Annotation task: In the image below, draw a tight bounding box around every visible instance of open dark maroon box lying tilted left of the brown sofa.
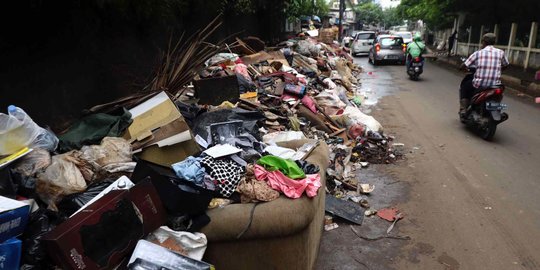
[42,180,166,270]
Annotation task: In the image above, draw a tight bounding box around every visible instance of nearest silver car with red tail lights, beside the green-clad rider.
[368,35,407,65]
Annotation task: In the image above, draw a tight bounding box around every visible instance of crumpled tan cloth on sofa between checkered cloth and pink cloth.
[237,164,279,203]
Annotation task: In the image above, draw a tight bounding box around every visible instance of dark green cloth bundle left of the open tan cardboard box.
[58,108,133,153]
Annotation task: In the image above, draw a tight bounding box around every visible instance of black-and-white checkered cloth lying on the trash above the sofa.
[201,156,245,198]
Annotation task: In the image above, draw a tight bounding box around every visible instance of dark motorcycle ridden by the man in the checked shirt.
[459,60,508,141]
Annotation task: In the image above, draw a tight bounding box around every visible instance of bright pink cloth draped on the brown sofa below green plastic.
[255,165,321,199]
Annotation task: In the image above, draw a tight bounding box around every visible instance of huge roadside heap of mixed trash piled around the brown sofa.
[0,30,398,269]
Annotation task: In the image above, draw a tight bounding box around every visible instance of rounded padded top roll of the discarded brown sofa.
[201,140,329,241]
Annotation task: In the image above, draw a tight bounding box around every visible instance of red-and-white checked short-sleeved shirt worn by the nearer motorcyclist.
[465,46,508,88]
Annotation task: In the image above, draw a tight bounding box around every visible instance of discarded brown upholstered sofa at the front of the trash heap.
[202,140,329,270]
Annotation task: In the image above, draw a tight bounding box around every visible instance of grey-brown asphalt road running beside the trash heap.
[356,57,540,269]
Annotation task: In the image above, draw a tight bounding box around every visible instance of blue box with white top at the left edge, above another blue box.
[0,196,30,242]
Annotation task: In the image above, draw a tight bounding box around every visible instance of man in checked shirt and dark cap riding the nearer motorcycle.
[459,33,509,116]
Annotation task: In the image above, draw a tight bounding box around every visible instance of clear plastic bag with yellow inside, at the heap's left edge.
[0,106,58,156]
